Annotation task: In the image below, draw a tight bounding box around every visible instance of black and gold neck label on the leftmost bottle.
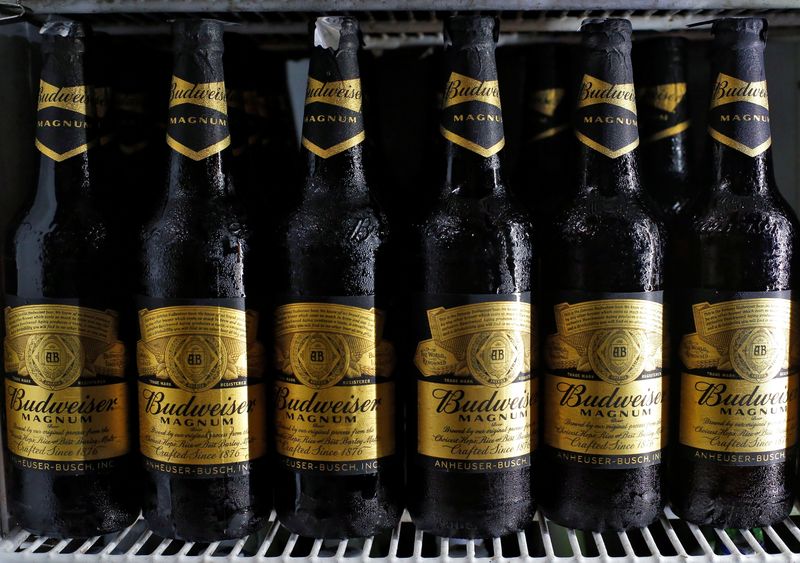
[36,77,96,162]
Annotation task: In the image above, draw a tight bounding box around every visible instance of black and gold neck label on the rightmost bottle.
[708,72,772,157]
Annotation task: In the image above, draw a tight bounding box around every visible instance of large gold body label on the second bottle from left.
[137,298,267,478]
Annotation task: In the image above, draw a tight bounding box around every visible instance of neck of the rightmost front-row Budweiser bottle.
[709,43,776,196]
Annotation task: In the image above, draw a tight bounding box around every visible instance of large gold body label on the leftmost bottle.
[4,304,131,472]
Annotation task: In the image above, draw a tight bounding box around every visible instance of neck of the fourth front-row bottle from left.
[440,38,505,198]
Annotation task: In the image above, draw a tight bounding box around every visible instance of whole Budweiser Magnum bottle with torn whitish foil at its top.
[273,16,402,538]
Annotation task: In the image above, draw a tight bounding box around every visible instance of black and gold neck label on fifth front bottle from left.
[575,74,639,158]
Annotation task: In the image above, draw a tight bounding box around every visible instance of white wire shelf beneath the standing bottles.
[0,510,800,563]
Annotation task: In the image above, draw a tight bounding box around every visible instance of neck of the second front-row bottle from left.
[167,46,233,200]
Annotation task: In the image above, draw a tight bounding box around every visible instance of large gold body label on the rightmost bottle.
[679,290,800,466]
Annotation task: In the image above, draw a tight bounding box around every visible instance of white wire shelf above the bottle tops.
[9,0,800,39]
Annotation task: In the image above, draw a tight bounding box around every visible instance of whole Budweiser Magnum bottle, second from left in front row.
[137,20,271,542]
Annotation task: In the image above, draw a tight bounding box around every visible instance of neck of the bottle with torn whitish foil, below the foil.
[301,43,369,199]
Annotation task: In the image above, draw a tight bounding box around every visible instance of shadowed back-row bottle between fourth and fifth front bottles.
[515,43,573,220]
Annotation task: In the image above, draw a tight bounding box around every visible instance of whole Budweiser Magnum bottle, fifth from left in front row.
[537,19,667,532]
